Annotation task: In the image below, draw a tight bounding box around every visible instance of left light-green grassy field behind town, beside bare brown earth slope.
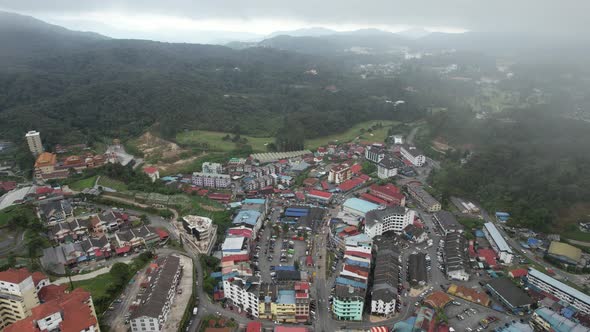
[176,130,274,152]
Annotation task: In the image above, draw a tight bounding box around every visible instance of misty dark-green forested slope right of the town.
[429,105,590,231]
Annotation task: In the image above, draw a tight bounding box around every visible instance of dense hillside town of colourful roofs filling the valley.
[0,127,590,332]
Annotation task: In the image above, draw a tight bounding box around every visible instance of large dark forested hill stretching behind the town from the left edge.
[0,12,432,144]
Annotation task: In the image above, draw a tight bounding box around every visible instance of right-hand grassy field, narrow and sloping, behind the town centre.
[305,120,398,149]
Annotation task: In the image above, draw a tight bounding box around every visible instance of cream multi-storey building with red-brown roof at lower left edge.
[0,269,40,330]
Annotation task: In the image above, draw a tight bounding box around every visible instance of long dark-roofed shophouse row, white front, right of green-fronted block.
[371,237,401,317]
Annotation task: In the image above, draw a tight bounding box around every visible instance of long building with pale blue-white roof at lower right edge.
[527,268,590,315]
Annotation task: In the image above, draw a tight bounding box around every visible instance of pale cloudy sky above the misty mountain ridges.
[0,0,590,42]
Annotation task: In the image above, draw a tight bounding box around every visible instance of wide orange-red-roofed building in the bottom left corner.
[4,288,100,332]
